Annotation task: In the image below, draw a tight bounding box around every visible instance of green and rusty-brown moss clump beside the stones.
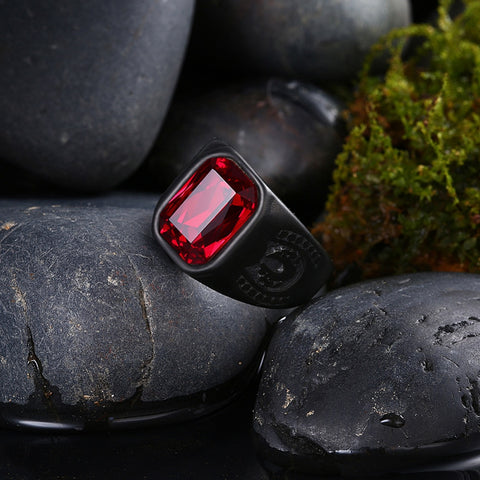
[314,0,480,277]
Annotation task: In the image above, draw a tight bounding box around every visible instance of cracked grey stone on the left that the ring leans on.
[0,204,268,429]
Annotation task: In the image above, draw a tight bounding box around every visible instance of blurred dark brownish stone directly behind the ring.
[148,79,343,222]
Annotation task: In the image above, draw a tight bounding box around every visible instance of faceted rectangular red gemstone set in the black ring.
[158,157,258,265]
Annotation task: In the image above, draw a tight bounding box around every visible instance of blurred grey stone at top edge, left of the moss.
[192,0,410,80]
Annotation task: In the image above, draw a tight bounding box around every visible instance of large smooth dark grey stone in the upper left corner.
[0,0,194,190]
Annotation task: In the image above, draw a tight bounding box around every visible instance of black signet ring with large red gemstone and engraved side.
[152,140,332,308]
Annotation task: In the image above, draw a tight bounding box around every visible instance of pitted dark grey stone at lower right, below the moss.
[254,273,480,475]
